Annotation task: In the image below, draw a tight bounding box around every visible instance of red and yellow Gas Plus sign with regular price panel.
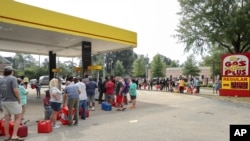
[220,53,250,96]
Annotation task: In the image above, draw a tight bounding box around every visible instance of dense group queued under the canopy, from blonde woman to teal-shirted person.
[43,76,137,128]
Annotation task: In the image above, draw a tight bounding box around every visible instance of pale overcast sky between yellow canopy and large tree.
[1,0,189,63]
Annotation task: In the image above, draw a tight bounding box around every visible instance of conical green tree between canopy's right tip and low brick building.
[151,54,166,77]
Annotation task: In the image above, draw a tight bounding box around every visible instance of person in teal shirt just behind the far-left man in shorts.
[17,78,28,120]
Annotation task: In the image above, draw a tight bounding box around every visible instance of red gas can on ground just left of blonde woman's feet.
[37,120,53,133]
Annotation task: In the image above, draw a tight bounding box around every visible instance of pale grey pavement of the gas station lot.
[0,85,250,141]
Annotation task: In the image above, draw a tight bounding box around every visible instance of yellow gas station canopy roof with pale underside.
[0,0,137,57]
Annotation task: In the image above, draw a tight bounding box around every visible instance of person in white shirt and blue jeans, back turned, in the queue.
[74,78,88,120]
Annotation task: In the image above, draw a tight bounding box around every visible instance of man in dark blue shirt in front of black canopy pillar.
[86,77,97,111]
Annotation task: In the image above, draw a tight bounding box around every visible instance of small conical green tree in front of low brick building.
[182,55,201,78]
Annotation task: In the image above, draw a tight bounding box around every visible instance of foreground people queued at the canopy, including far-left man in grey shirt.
[0,67,137,140]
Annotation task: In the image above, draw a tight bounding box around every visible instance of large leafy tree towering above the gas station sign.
[175,0,250,53]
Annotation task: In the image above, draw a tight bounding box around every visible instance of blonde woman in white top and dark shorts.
[49,78,62,128]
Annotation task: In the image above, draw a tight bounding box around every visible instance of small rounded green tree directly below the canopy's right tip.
[132,56,146,77]
